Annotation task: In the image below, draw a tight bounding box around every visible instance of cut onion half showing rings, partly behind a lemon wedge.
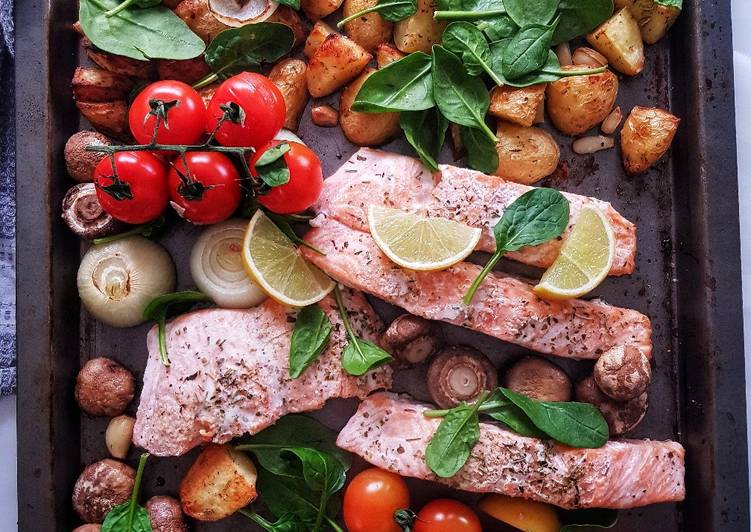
[190,219,266,308]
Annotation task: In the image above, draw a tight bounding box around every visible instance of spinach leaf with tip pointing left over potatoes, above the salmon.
[352,52,435,113]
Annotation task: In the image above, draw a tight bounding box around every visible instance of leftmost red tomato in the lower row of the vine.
[94,151,169,224]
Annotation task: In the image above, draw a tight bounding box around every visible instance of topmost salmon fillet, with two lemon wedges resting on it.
[311,148,636,275]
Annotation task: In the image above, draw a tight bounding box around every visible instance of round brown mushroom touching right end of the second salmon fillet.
[593,345,652,401]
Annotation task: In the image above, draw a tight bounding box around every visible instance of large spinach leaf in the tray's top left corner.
[78,0,206,61]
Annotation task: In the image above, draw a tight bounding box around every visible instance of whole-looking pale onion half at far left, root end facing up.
[78,236,175,327]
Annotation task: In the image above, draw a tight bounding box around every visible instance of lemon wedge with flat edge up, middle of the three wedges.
[368,205,482,271]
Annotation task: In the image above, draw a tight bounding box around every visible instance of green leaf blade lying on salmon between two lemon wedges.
[493,188,569,252]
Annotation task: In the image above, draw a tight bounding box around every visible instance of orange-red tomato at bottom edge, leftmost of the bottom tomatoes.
[344,467,409,532]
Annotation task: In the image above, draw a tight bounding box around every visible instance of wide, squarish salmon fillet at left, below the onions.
[133,291,391,456]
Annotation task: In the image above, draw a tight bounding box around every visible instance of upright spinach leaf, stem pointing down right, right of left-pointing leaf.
[433,45,498,142]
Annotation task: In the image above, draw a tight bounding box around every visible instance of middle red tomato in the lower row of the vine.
[168,151,242,225]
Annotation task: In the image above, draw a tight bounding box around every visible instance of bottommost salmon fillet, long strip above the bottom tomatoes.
[336,393,685,509]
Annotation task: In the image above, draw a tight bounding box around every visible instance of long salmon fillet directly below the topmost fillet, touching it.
[303,219,652,359]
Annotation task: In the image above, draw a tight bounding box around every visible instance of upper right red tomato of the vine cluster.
[206,72,286,148]
